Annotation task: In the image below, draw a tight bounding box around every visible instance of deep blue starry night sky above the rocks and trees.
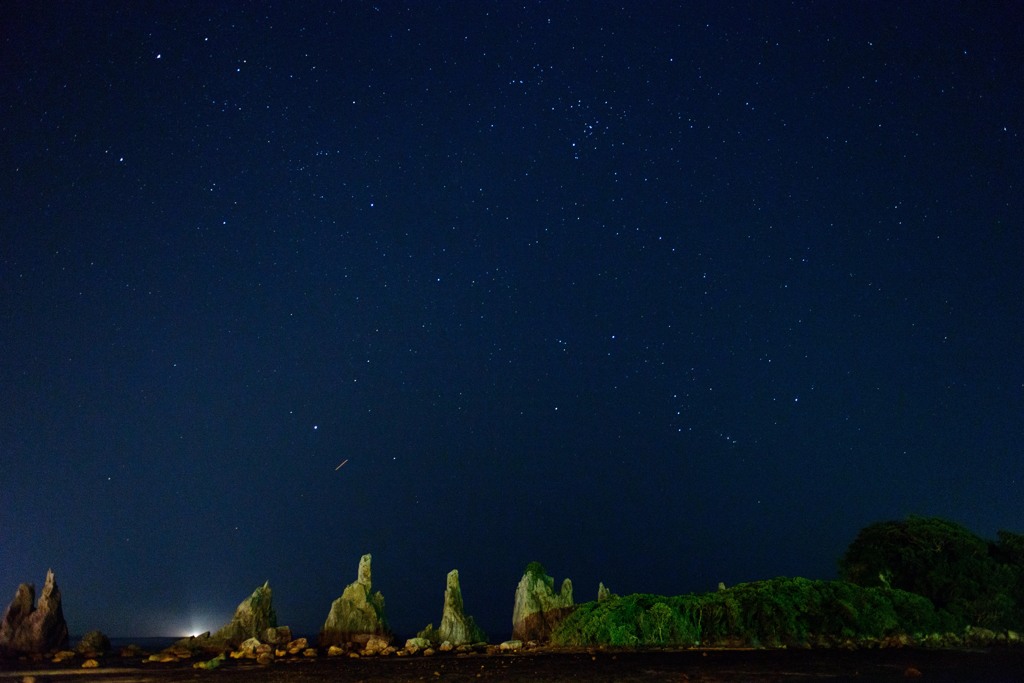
[0,0,1024,641]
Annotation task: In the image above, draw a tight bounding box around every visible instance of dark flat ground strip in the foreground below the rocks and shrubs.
[0,649,1024,683]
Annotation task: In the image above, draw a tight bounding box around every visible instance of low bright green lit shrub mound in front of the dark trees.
[552,578,947,646]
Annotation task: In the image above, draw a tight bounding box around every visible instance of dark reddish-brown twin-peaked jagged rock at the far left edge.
[0,569,68,653]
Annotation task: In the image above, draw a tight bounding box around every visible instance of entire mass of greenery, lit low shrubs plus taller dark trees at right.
[552,517,1024,647]
